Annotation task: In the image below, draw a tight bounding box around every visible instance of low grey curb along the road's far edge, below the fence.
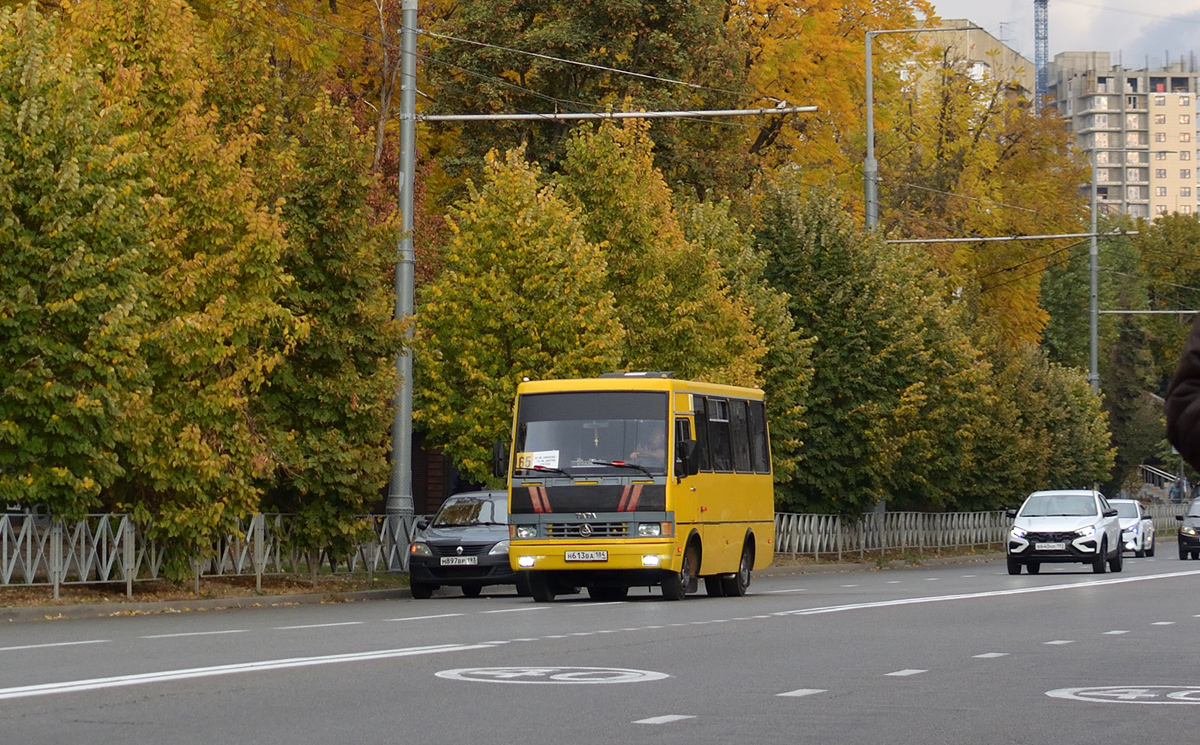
[0,553,1004,624]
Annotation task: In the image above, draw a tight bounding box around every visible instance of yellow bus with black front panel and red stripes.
[494,372,775,602]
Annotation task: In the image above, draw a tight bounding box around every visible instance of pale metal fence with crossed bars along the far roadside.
[0,504,1187,597]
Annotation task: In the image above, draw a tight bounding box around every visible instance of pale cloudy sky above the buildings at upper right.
[932,0,1200,70]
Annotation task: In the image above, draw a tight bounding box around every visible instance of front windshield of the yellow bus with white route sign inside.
[514,391,668,477]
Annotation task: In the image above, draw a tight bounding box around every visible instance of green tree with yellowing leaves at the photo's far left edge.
[0,5,151,521]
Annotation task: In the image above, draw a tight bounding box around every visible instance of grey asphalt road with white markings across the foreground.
[0,551,1200,745]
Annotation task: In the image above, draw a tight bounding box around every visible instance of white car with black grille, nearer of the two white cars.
[1007,489,1124,575]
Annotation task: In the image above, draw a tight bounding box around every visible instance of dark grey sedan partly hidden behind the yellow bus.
[408,492,527,600]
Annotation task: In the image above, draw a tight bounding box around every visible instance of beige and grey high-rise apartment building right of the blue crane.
[1049,52,1200,217]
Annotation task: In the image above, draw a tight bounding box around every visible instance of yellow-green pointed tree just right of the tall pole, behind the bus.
[414,151,625,481]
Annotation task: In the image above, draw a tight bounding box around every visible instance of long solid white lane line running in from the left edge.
[0,644,490,701]
